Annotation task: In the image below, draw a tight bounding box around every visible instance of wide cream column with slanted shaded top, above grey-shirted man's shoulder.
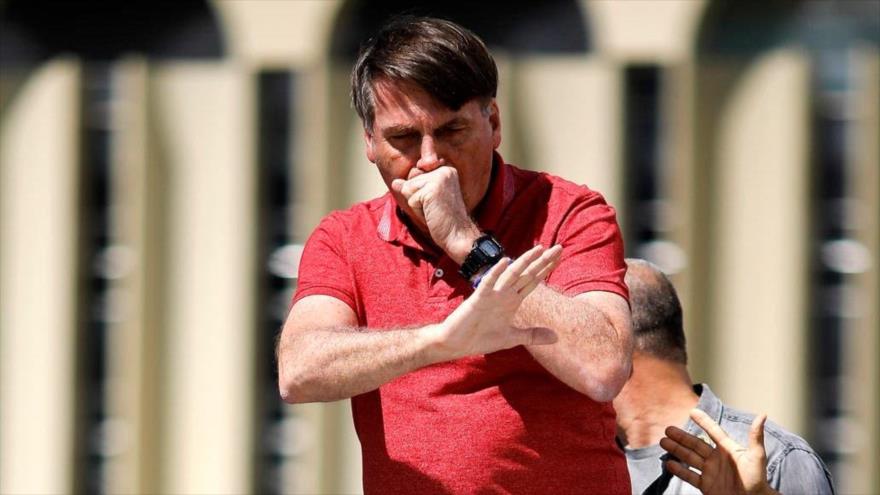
[706,50,809,433]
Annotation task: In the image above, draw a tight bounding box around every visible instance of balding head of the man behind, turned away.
[626,258,687,364]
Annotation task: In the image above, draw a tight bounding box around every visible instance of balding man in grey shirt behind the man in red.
[614,259,834,494]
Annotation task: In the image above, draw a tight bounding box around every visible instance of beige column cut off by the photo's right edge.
[835,46,880,493]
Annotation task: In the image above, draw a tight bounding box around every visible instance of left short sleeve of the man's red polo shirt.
[292,214,357,312]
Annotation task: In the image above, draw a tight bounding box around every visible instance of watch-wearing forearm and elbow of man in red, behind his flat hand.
[514,284,633,402]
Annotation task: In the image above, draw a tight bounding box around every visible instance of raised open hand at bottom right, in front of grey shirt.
[660,409,776,495]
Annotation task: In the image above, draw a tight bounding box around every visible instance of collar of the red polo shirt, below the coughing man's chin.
[376,152,516,251]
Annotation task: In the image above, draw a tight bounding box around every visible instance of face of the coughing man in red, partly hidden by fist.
[364,79,501,218]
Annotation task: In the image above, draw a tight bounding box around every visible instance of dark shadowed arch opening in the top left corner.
[0,0,226,112]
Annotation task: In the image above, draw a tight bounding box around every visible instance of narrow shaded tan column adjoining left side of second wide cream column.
[105,58,167,493]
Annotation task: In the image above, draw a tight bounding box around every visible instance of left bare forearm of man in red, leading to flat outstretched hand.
[278,326,438,403]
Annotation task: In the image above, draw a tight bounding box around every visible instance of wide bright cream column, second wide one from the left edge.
[149,63,256,494]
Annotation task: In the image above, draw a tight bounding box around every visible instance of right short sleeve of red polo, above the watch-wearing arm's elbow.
[547,191,629,300]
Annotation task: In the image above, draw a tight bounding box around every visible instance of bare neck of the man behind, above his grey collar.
[614,355,699,449]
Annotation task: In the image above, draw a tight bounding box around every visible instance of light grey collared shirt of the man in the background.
[624,384,834,495]
